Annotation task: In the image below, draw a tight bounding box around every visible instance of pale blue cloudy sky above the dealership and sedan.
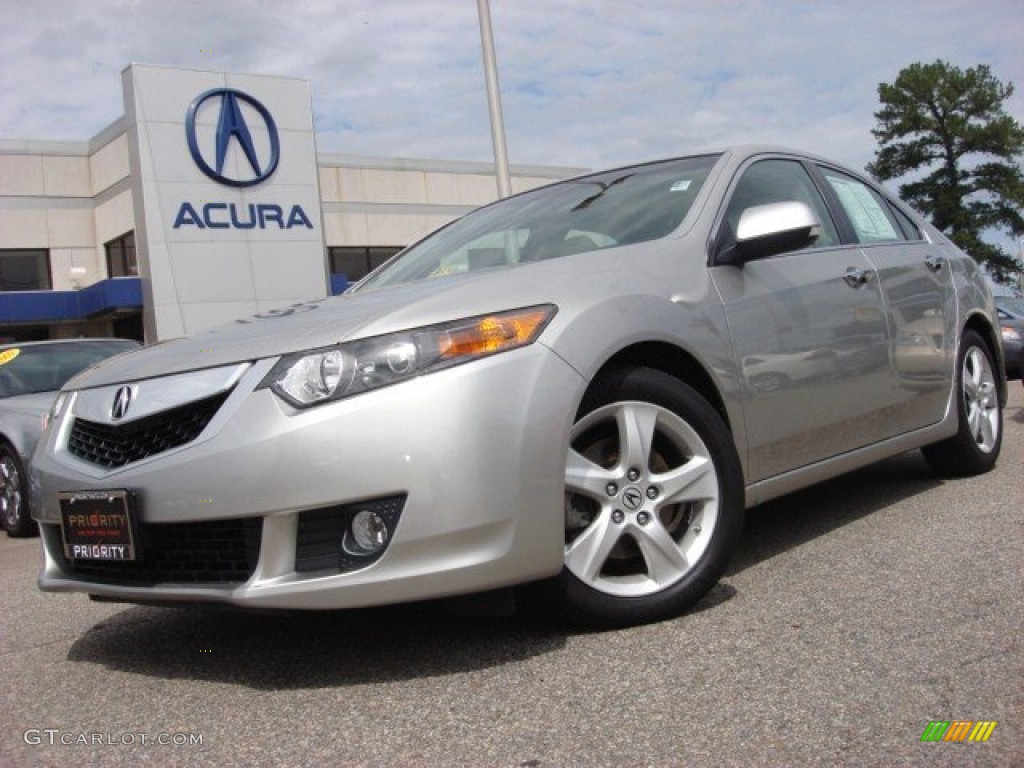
[0,0,1024,180]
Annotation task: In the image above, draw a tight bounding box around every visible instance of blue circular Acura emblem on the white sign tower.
[185,88,281,186]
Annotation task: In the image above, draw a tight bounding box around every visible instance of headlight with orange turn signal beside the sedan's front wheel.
[260,304,557,408]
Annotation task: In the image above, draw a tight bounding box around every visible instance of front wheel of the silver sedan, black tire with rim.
[556,369,744,627]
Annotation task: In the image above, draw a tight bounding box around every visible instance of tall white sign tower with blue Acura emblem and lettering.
[123,65,328,342]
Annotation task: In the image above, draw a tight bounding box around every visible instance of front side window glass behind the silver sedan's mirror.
[719,160,839,248]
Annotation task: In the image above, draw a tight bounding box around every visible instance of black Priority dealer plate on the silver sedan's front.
[58,490,136,560]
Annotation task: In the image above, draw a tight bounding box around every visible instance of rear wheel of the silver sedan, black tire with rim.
[921,331,1002,477]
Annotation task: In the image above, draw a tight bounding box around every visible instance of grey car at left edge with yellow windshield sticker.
[0,339,140,537]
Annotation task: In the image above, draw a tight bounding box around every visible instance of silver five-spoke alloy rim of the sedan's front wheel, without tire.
[565,401,720,597]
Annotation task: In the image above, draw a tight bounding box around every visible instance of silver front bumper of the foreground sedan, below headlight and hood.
[32,344,584,609]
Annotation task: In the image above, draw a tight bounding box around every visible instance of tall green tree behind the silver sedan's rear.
[867,59,1024,283]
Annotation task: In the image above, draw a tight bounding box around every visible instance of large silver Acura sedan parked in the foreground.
[32,146,1007,626]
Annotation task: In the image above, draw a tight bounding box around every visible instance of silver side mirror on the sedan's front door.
[718,201,821,266]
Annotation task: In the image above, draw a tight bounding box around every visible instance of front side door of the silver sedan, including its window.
[711,158,889,481]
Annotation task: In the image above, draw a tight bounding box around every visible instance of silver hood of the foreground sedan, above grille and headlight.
[65,258,579,390]
